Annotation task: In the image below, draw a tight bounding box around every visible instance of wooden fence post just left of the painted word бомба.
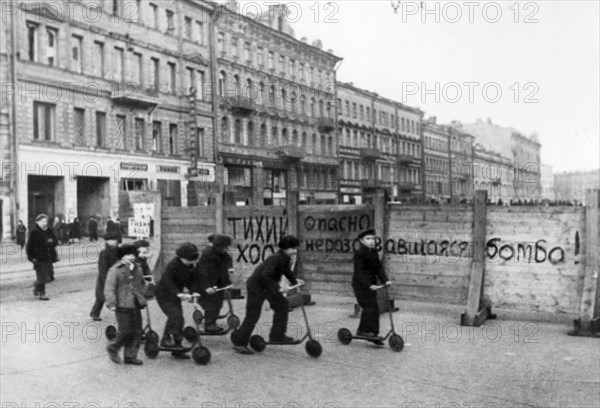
[460,190,496,326]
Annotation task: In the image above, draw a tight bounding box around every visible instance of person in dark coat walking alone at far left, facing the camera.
[26,214,58,300]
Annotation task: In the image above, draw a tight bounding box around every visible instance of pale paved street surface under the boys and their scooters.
[0,274,600,408]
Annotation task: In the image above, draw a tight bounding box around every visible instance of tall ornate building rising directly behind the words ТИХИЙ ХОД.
[215,2,341,205]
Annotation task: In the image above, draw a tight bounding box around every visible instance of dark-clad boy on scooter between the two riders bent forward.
[193,234,233,334]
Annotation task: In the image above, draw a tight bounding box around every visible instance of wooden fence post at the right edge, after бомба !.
[568,190,600,337]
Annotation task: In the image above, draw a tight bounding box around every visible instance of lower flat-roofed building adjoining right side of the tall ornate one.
[337,82,423,204]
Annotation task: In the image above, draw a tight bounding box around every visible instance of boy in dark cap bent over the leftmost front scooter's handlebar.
[155,243,200,359]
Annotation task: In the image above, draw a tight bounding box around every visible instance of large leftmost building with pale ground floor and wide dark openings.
[2,0,215,236]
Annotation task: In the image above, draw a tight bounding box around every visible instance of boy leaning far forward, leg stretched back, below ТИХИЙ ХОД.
[231,235,304,354]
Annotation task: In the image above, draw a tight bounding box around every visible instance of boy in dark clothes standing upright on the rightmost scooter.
[352,228,392,344]
